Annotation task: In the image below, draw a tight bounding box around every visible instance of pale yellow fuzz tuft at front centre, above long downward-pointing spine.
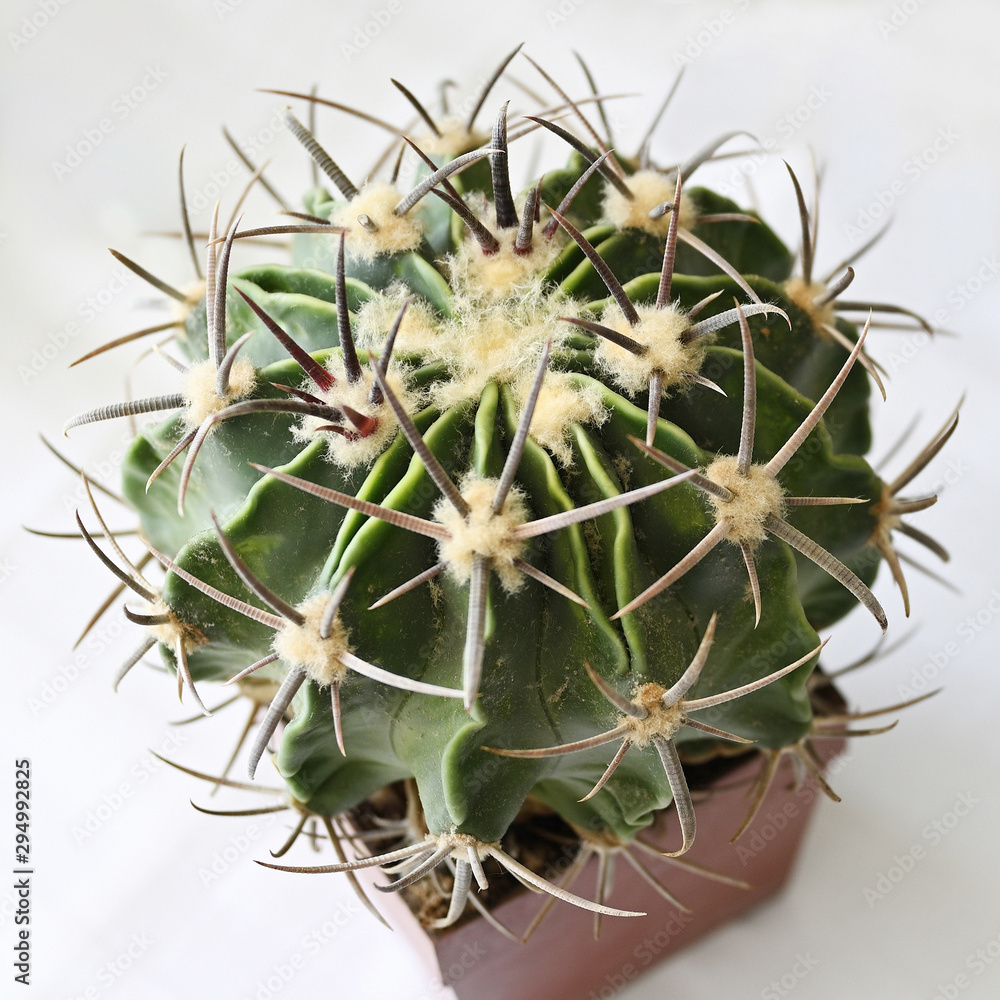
[434,477,528,593]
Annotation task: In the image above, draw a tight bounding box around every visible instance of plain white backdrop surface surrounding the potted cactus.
[0,0,1000,1000]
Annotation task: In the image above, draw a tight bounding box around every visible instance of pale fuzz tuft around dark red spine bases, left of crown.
[293,354,419,469]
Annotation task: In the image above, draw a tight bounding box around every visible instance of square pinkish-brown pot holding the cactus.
[368,740,843,1000]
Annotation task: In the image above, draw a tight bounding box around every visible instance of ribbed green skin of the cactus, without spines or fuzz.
[124,141,883,842]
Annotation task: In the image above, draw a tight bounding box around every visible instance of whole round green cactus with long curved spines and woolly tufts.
[62,50,957,927]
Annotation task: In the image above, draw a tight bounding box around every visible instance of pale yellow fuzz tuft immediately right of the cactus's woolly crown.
[595,303,705,396]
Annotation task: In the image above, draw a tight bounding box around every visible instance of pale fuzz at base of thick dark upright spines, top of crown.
[449,225,561,301]
